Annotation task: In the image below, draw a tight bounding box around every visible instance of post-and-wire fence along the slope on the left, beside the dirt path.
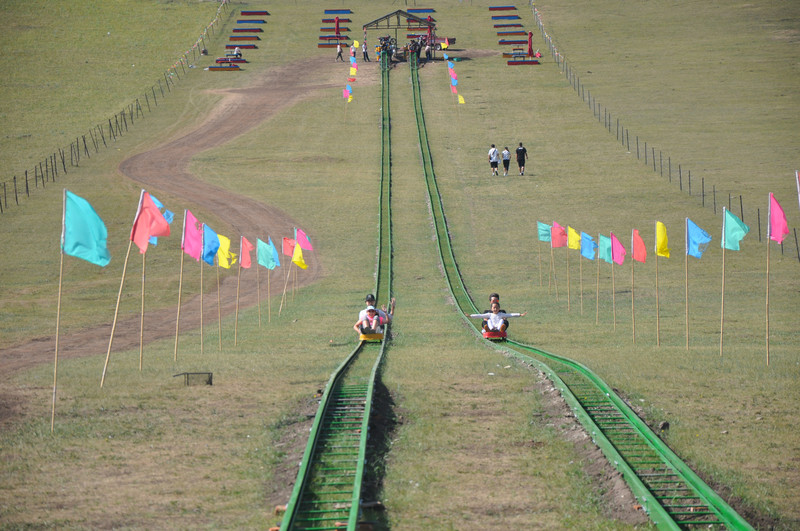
[0,0,230,214]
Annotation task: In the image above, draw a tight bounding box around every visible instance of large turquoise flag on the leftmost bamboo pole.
[61,190,111,267]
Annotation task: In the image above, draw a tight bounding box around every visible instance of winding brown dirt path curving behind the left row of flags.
[0,56,341,378]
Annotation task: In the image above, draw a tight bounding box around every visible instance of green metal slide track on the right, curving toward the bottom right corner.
[411,55,752,530]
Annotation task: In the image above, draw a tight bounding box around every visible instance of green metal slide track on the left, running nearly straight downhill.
[281,57,392,531]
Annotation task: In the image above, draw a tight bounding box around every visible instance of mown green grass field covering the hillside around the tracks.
[0,0,800,529]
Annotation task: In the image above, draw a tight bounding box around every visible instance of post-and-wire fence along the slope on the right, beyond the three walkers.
[530,0,800,262]
